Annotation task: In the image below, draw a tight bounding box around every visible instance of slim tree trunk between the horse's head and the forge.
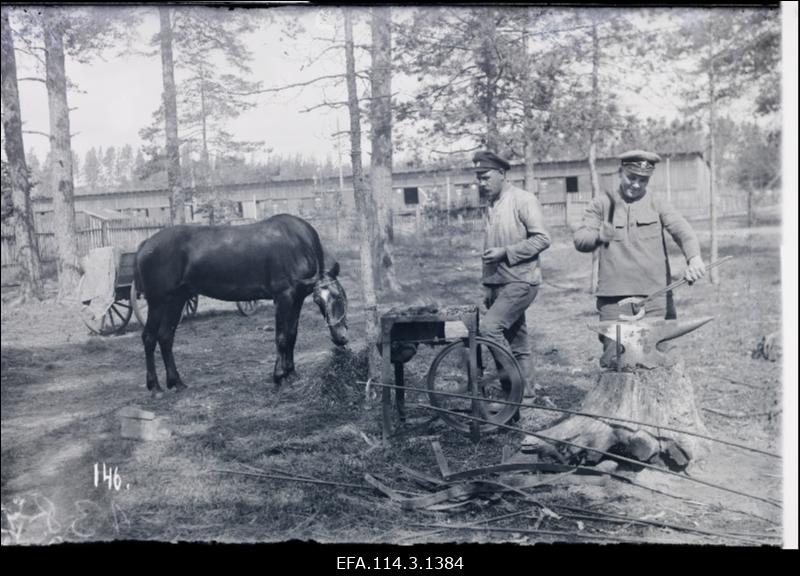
[342,8,381,378]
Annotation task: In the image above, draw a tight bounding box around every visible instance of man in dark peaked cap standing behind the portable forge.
[472,151,550,404]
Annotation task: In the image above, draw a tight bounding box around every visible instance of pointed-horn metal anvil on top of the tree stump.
[589,316,714,370]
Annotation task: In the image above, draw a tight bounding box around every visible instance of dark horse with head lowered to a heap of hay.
[135,214,347,395]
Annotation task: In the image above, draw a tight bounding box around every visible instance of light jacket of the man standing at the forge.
[483,183,550,286]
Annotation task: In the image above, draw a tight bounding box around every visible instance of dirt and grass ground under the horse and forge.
[1,216,782,546]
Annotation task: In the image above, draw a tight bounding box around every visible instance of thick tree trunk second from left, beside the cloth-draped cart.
[42,7,80,301]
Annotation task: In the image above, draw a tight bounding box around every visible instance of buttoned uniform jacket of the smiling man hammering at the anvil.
[574,193,700,296]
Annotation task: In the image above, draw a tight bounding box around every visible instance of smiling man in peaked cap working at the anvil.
[574,150,705,367]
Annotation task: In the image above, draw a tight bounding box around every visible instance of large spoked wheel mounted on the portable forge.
[427,336,524,433]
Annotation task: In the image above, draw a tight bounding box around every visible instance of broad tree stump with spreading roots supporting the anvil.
[522,361,708,470]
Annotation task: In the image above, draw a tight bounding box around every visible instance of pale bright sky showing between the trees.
[9,7,788,163]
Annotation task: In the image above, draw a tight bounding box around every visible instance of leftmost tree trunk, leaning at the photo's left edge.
[0,11,44,302]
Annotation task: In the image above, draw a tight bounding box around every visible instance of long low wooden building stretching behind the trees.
[2,152,746,269]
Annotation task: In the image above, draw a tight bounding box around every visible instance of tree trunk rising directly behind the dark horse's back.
[158,6,186,224]
